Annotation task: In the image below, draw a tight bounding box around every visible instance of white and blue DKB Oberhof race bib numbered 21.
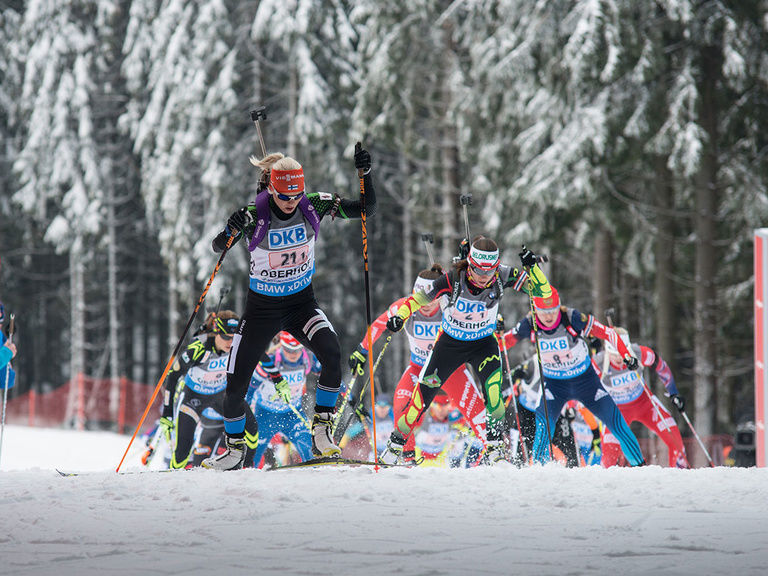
[250,210,315,296]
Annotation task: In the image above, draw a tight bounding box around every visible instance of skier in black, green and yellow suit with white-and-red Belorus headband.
[381,236,550,464]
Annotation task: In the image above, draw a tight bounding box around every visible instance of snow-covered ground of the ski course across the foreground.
[0,426,768,576]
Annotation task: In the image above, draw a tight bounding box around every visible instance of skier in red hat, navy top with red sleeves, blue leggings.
[504,287,645,466]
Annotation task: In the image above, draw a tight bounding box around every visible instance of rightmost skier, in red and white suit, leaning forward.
[594,328,690,468]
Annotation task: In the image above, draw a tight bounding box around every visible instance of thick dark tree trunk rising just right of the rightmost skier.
[694,47,721,436]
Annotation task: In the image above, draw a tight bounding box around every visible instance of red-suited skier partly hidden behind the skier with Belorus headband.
[349,264,486,461]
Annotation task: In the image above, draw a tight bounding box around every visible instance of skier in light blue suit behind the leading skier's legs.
[245,332,321,466]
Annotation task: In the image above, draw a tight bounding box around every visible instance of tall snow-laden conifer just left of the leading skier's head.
[121,0,240,341]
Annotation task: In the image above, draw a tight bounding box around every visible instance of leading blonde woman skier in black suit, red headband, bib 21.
[203,147,376,470]
